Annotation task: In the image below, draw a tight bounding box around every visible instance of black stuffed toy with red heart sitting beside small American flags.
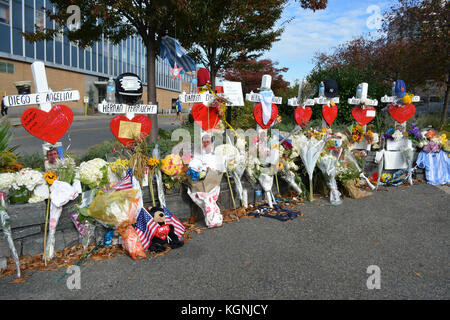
[148,207,184,252]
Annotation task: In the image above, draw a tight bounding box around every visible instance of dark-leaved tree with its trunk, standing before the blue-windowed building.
[25,0,187,141]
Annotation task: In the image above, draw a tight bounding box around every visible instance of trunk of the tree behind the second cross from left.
[145,40,160,142]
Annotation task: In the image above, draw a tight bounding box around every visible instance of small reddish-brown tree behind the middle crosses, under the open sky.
[218,59,289,95]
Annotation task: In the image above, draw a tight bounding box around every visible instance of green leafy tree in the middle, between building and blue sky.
[179,0,327,86]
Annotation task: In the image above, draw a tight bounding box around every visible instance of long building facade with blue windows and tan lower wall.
[0,0,191,111]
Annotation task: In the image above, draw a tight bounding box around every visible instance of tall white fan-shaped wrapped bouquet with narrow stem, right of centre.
[293,134,325,201]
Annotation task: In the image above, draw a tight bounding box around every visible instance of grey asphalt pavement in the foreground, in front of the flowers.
[0,184,450,300]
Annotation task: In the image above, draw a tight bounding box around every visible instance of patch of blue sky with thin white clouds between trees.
[260,0,396,85]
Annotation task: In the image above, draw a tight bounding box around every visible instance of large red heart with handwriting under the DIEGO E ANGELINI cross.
[21,105,73,144]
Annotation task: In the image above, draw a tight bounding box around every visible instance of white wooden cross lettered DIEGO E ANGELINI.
[3,61,80,112]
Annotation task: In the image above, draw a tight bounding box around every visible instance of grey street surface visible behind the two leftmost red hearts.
[11,116,186,155]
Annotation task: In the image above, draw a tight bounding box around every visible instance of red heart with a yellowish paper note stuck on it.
[109,114,152,146]
